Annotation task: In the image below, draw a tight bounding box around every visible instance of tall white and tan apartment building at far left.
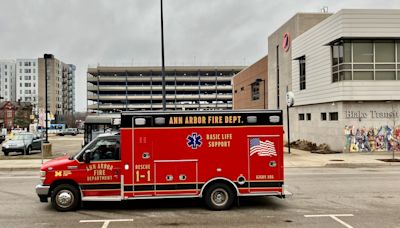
[0,56,76,115]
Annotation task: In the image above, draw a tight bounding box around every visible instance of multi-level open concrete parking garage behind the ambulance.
[87,66,244,113]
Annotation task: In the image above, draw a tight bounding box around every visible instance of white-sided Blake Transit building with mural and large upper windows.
[288,9,400,152]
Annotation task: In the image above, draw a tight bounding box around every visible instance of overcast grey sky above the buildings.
[0,0,400,111]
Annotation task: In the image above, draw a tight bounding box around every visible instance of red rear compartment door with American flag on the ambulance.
[247,135,283,193]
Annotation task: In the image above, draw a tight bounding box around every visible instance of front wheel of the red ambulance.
[51,184,81,211]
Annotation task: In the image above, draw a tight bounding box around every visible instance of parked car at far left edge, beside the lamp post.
[2,133,43,156]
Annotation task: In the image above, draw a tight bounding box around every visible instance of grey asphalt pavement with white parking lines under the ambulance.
[0,166,400,228]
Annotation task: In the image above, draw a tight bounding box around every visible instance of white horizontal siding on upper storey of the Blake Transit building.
[292,9,400,105]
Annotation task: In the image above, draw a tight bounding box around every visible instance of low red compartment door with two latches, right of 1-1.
[154,160,200,196]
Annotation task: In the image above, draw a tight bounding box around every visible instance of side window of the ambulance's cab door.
[89,139,120,161]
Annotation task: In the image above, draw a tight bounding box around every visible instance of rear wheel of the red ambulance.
[203,183,236,211]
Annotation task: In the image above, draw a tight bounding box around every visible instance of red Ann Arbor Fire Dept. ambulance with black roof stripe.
[36,110,285,211]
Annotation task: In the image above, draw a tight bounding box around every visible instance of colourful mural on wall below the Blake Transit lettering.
[344,125,400,152]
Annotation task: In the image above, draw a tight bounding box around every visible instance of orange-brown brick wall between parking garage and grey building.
[232,56,268,109]
